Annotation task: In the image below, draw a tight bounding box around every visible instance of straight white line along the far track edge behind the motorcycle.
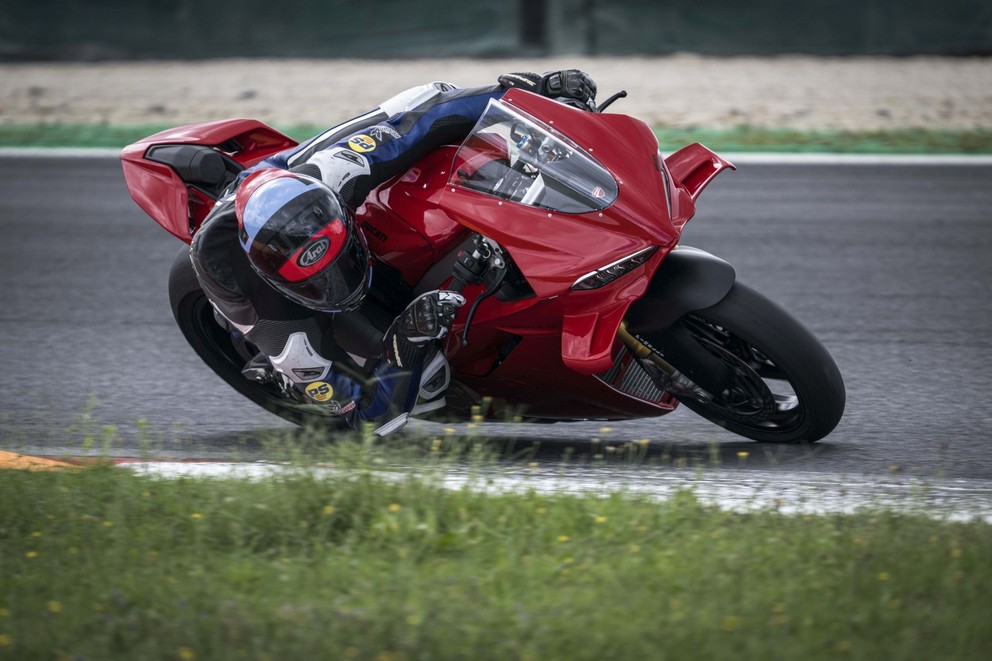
[0,147,992,167]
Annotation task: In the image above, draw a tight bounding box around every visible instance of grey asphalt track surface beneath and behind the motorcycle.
[0,155,992,486]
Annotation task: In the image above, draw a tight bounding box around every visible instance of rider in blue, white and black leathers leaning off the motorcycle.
[190,69,596,434]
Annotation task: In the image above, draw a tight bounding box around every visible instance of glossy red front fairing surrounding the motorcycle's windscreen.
[380,90,676,376]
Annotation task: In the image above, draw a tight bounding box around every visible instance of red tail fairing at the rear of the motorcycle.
[121,119,297,243]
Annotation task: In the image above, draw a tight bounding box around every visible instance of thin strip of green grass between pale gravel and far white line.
[0,124,992,154]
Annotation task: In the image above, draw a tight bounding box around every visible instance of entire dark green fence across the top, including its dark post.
[0,0,992,61]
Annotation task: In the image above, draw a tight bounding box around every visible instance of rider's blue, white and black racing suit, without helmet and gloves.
[200,82,505,433]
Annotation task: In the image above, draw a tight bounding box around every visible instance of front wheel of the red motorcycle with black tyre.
[645,283,846,443]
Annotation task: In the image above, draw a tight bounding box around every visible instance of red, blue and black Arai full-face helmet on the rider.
[234,168,372,312]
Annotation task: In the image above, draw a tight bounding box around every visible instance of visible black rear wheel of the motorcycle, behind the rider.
[169,248,347,429]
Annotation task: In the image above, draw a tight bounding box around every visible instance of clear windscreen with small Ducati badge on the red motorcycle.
[451,101,619,213]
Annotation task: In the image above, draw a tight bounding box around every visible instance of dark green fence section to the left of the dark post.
[0,0,520,59]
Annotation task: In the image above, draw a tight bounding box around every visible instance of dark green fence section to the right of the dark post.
[549,0,992,55]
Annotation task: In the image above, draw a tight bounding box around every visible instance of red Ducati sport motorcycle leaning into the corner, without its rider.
[121,89,845,442]
